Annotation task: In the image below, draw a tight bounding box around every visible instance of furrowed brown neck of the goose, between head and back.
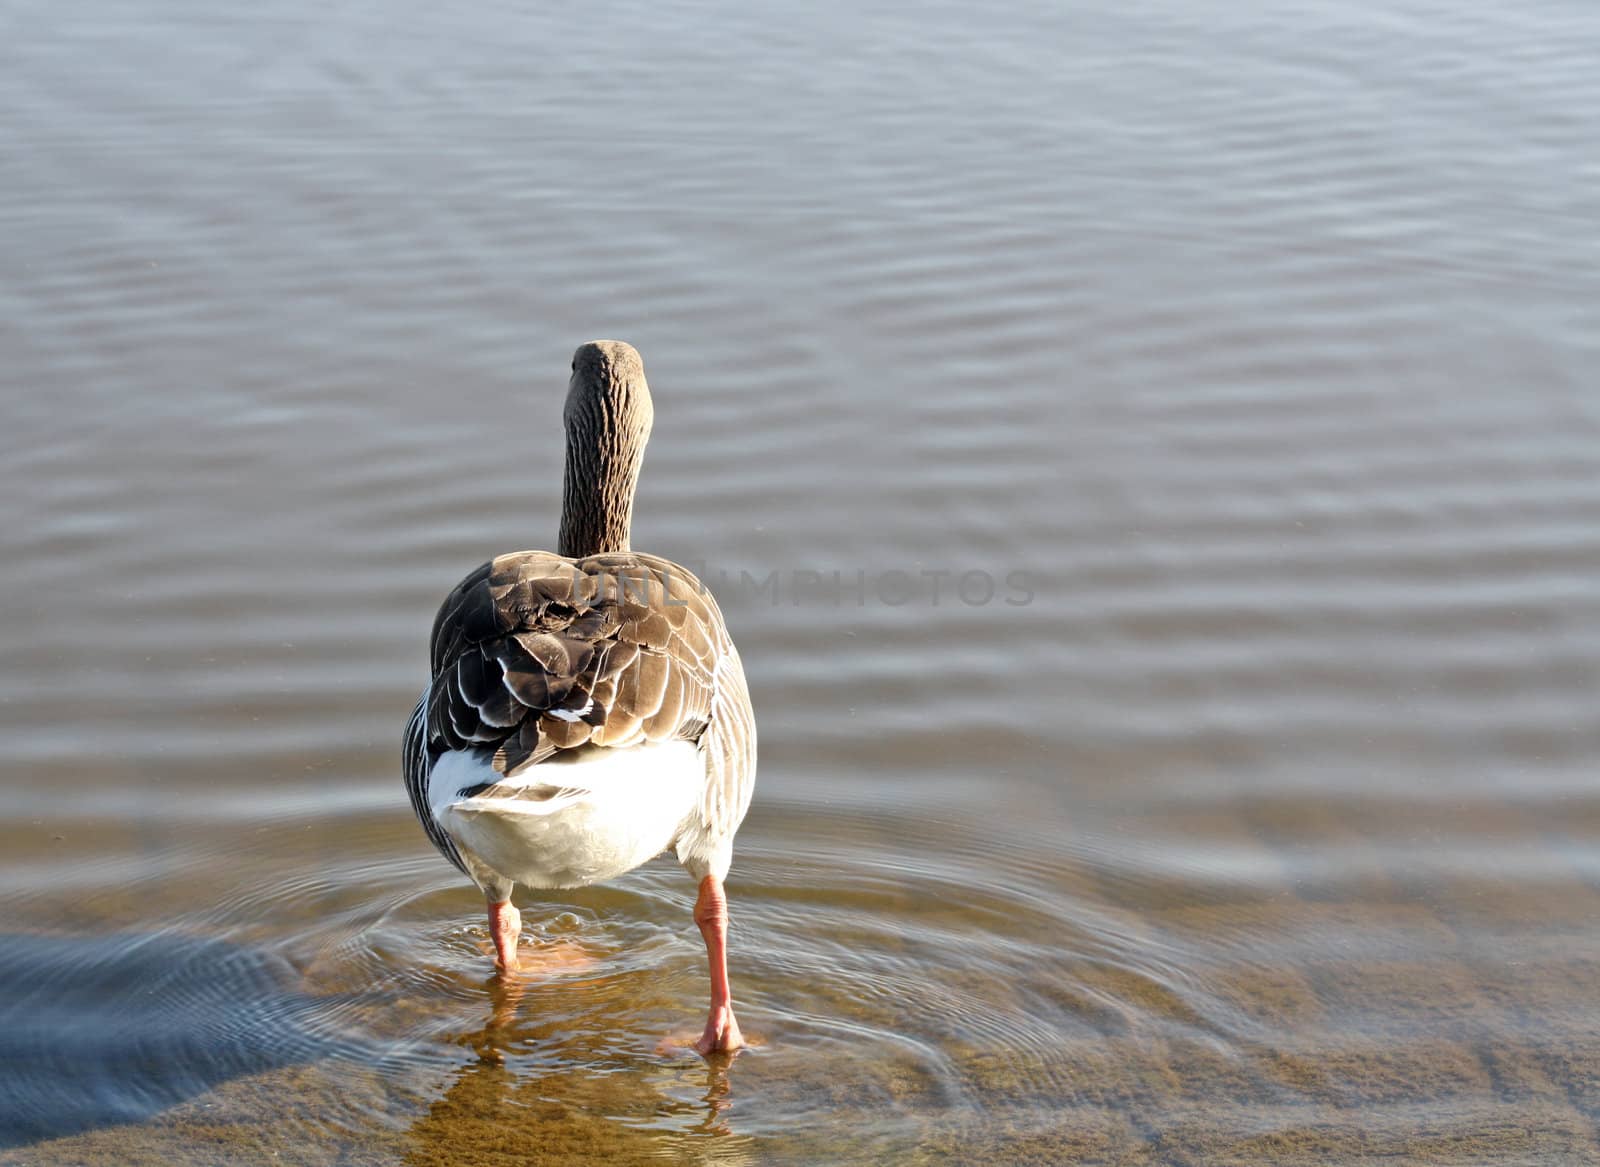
[557,416,645,559]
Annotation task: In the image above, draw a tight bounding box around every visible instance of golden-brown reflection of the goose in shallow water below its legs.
[406,977,754,1165]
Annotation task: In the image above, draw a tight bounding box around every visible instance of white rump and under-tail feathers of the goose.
[427,741,706,887]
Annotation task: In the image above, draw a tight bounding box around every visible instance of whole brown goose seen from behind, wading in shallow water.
[403,341,755,1055]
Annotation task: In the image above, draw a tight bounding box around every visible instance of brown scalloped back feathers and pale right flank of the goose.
[426,551,754,831]
